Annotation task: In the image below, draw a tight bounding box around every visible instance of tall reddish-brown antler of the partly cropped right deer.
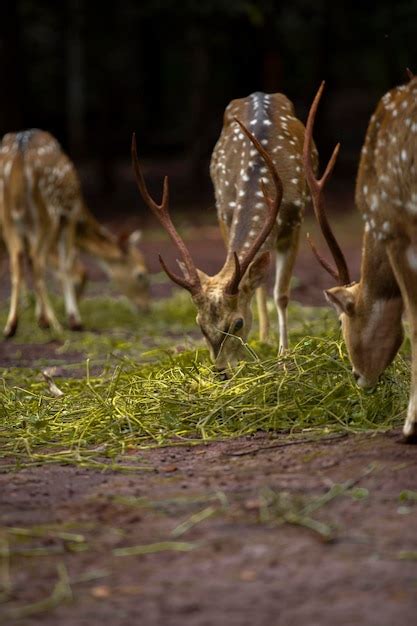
[303,81,350,285]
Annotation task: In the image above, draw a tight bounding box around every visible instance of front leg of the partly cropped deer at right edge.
[388,241,417,442]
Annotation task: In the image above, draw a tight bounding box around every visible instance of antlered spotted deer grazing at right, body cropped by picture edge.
[304,78,417,440]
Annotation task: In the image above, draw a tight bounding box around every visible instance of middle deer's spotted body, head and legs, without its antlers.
[194,93,317,369]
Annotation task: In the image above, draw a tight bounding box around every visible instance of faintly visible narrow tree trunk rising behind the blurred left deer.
[67,0,85,157]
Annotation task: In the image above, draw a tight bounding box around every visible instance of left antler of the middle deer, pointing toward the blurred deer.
[132,133,201,295]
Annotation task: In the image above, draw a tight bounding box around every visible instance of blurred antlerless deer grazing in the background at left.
[0,129,148,337]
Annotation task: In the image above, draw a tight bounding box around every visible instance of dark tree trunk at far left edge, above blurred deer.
[0,0,26,136]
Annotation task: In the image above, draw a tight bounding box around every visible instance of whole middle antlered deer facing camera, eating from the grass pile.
[132,93,317,370]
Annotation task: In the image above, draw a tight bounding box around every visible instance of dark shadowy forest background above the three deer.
[0,0,417,211]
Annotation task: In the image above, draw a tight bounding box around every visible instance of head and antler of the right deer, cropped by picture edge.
[303,82,403,387]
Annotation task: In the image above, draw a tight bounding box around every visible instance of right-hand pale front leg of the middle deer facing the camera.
[274,226,300,353]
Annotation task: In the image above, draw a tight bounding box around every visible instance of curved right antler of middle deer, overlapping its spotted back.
[226,117,283,295]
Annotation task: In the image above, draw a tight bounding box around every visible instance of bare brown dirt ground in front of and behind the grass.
[0,207,417,626]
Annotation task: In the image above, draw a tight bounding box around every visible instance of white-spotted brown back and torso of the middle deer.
[210,92,317,256]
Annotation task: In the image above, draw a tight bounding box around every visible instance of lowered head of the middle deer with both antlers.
[132,120,282,370]
